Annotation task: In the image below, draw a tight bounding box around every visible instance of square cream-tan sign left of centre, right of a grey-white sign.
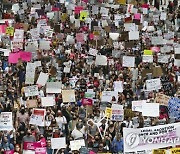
[62,90,76,103]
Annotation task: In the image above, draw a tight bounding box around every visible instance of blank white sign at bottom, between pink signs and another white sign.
[51,137,66,149]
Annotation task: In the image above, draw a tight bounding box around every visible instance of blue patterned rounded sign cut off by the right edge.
[168,97,180,120]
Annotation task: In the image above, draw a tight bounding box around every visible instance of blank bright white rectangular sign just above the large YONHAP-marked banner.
[142,103,159,117]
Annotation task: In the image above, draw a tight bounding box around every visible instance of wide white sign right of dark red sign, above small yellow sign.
[101,91,118,102]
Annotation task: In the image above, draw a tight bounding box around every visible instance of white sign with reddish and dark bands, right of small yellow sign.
[111,104,124,121]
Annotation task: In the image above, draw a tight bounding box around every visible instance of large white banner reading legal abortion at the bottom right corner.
[123,123,180,152]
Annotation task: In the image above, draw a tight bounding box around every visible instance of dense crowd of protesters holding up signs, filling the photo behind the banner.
[0,0,180,154]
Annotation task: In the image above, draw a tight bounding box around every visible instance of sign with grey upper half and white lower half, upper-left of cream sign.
[46,82,62,94]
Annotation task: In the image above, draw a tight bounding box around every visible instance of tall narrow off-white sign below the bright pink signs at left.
[25,63,36,84]
